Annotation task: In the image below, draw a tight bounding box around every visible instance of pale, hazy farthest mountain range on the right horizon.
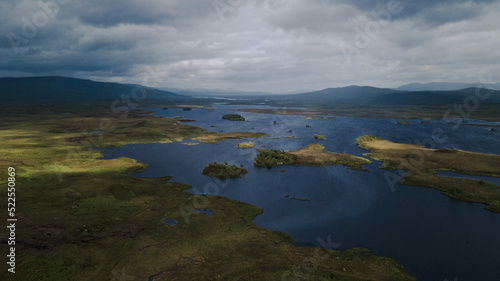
[397,82,500,91]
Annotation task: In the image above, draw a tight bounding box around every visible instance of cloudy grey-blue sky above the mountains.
[0,0,500,93]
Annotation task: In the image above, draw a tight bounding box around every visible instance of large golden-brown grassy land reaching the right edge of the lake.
[356,135,500,212]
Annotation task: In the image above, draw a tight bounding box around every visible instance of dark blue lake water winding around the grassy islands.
[99,105,500,281]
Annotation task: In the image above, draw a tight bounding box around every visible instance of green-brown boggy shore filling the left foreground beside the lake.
[0,105,414,281]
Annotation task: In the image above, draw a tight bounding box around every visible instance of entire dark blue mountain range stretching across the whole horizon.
[0,76,500,105]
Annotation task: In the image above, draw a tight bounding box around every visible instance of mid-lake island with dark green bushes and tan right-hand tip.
[254,144,371,170]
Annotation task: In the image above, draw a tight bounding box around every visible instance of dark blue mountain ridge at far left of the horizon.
[0,76,193,103]
